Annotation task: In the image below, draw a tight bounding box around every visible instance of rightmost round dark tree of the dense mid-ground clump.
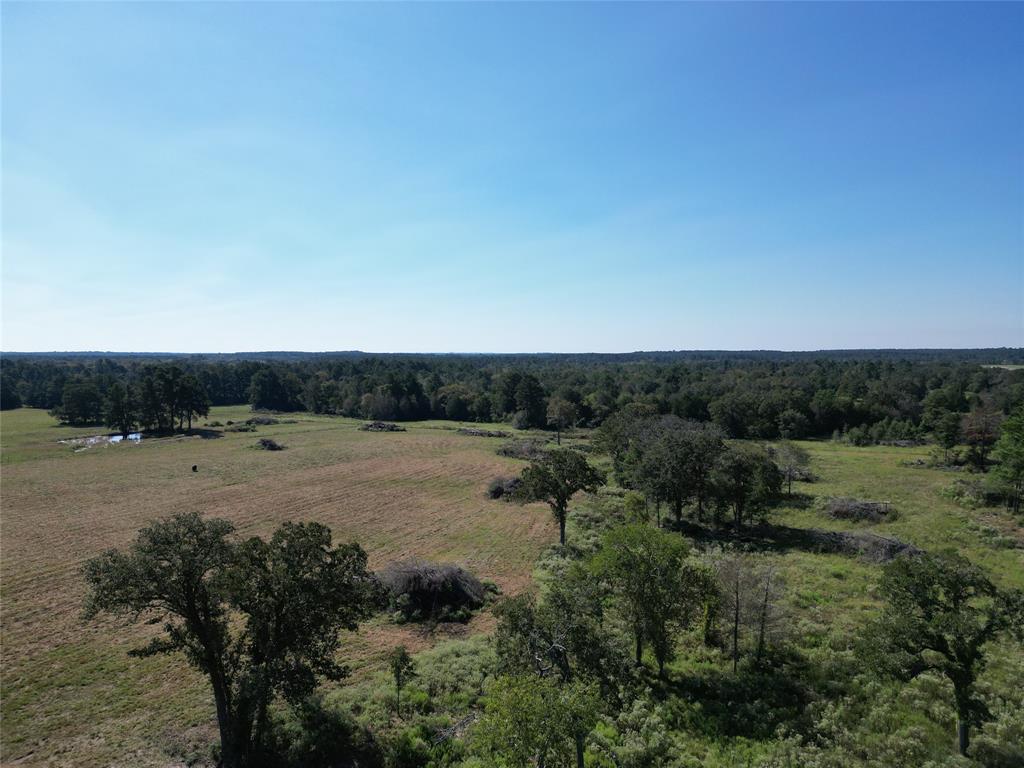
[713,444,782,534]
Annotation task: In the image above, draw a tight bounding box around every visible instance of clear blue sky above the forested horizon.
[0,2,1024,351]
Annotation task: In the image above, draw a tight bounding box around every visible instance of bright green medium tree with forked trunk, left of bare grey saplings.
[593,524,713,675]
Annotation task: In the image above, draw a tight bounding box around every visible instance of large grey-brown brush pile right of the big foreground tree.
[380,560,486,622]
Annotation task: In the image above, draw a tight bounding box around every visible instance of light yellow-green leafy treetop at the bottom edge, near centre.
[472,675,600,768]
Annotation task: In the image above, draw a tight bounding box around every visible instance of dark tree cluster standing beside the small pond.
[50,365,210,435]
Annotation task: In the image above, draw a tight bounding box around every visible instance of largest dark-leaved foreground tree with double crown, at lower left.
[85,513,376,768]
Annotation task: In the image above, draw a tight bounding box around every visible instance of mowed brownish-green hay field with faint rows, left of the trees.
[0,408,557,766]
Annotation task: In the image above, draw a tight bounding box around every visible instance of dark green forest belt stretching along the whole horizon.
[0,349,1024,441]
